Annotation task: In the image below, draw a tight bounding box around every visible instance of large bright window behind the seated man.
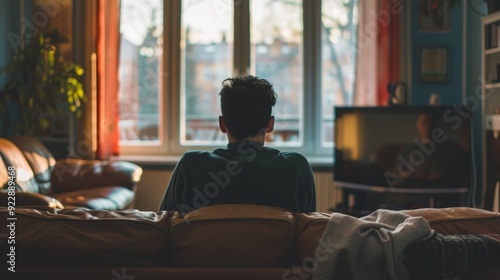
[119,0,358,157]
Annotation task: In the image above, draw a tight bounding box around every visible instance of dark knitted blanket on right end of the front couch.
[404,234,500,280]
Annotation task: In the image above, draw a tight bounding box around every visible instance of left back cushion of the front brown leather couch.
[0,208,172,266]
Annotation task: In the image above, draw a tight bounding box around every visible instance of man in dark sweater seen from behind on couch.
[160,76,316,213]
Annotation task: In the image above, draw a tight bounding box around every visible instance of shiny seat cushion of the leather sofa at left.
[52,186,134,210]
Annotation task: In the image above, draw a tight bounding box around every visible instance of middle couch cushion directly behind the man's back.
[169,204,295,267]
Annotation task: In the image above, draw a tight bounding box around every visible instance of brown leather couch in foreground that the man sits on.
[0,205,500,280]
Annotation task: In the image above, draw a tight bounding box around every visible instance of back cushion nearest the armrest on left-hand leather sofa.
[12,136,56,194]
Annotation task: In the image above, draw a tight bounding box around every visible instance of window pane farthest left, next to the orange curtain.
[119,0,163,145]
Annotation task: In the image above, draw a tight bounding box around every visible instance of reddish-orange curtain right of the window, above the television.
[354,0,403,106]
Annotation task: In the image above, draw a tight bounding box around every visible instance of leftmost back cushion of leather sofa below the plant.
[0,138,40,193]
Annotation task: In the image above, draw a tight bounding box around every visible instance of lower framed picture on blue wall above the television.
[417,47,450,83]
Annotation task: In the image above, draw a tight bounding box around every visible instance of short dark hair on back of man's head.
[219,76,277,140]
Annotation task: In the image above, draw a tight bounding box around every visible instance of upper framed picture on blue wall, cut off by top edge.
[418,0,450,32]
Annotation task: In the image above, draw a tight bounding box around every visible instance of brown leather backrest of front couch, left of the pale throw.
[0,205,328,268]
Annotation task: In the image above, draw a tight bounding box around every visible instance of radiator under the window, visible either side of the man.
[134,169,342,212]
